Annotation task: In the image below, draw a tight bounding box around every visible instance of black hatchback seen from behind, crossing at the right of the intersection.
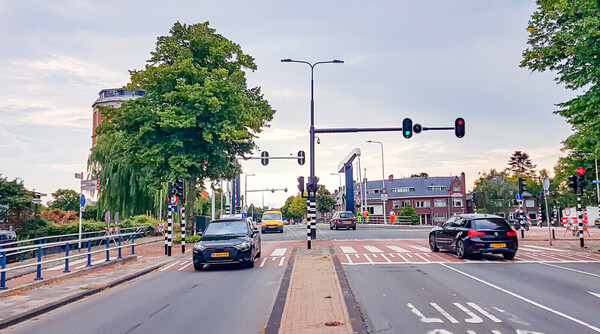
[429,214,519,260]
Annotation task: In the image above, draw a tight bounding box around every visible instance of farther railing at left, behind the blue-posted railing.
[0,225,147,262]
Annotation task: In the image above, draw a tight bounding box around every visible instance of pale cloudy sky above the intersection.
[0,0,575,207]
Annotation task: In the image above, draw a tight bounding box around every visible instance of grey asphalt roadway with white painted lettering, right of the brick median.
[344,262,600,334]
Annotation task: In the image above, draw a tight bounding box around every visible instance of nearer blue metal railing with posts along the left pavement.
[0,232,140,290]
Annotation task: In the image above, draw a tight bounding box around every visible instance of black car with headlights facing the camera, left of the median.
[193,218,261,270]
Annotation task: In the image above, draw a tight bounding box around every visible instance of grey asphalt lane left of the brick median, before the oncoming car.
[3,266,285,334]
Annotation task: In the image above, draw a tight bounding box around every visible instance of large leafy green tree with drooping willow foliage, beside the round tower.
[90,22,275,222]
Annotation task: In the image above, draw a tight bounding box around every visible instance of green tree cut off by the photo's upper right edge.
[521,0,600,200]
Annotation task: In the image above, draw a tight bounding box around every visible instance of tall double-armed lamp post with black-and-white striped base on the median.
[281,58,344,245]
